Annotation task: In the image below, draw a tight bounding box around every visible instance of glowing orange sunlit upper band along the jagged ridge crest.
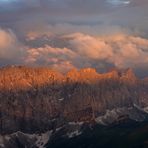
[0,66,137,89]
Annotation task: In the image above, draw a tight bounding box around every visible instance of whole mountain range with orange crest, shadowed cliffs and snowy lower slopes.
[0,66,148,148]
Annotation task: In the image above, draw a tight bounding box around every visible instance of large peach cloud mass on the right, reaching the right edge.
[64,34,148,68]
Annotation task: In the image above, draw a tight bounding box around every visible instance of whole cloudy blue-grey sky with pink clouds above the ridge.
[0,0,148,77]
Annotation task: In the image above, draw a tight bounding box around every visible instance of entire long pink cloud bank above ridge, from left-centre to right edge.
[25,33,148,71]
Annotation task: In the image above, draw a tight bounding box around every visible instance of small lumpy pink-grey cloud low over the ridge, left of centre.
[25,45,77,71]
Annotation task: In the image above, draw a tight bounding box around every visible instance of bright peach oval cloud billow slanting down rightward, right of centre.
[69,34,113,60]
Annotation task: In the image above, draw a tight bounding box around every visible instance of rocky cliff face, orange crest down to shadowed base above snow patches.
[0,66,148,134]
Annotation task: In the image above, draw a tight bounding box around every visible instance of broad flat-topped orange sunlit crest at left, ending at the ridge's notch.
[0,66,64,90]
